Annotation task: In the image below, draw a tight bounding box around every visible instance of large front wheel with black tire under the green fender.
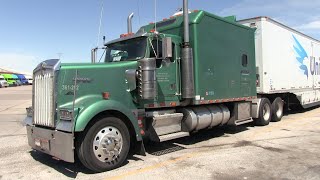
[77,117,130,172]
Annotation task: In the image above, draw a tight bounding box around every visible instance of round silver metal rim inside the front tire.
[93,126,123,163]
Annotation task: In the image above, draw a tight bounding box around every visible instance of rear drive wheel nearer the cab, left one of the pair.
[255,98,272,126]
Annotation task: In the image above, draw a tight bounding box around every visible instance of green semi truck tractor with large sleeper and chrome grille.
[26,0,272,172]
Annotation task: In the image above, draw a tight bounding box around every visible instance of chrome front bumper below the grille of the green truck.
[26,124,74,162]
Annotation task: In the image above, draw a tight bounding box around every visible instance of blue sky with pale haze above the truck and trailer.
[0,0,320,72]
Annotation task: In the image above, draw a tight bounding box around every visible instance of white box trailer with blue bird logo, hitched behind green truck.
[238,17,320,121]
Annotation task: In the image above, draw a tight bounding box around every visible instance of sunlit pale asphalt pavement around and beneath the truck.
[0,86,320,180]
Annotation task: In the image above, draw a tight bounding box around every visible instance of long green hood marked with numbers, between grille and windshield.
[56,61,137,108]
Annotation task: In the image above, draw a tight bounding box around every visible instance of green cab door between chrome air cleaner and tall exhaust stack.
[149,40,180,103]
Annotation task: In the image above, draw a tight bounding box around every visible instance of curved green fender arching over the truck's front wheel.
[75,100,142,141]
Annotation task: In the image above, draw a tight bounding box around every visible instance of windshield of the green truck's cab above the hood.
[105,37,147,62]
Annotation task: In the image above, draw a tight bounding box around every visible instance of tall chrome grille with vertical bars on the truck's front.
[33,71,54,127]
